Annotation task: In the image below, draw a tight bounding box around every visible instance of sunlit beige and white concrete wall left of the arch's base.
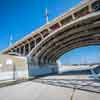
[0,54,28,80]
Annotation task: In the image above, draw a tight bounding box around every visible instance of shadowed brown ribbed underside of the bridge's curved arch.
[29,12,100,65]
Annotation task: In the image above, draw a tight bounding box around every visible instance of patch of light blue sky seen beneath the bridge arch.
[60,46,100,64]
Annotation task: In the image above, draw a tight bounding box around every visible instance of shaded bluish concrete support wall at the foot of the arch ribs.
[28,57,58,78]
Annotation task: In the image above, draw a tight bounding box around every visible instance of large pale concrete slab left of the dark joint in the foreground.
[0,82,72,100]
